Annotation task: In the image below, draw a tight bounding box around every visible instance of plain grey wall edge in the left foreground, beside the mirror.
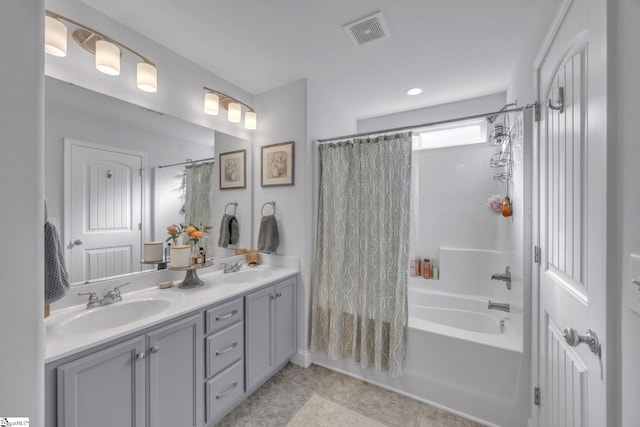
[0,0,44,427]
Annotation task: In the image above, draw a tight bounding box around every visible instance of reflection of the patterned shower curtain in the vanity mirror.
[184,162,214,258]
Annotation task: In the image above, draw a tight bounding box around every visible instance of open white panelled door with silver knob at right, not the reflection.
[534,0,607,427]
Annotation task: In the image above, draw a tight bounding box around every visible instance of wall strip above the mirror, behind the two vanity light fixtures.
[45,0,254,140]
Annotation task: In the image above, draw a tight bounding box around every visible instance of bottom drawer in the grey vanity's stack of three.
[205,361,244,422]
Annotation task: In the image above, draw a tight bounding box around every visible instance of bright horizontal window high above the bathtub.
[413,119,487,151]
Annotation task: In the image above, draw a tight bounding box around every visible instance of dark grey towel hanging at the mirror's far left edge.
[44,221,69,304]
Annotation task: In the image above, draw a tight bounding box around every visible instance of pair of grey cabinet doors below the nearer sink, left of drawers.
[57,314,204,427]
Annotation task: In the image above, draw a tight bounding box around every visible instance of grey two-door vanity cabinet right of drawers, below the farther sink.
[245,277,296,392]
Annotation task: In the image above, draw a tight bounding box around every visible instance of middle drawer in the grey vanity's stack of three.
[205,322,244,378]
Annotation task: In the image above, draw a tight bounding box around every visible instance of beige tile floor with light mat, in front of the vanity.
[217,363,481,427]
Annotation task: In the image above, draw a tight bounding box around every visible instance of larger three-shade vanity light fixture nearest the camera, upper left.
[44,10,158,92]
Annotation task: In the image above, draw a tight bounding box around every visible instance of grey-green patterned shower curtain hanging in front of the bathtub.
[311,133,411,376]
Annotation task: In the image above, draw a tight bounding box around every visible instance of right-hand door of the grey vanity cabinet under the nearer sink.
[147,315,203,427]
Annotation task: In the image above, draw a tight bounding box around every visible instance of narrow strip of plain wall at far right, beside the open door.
[607,0,640,427]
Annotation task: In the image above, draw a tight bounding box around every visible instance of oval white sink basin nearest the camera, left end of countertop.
[51,299,171,334]
